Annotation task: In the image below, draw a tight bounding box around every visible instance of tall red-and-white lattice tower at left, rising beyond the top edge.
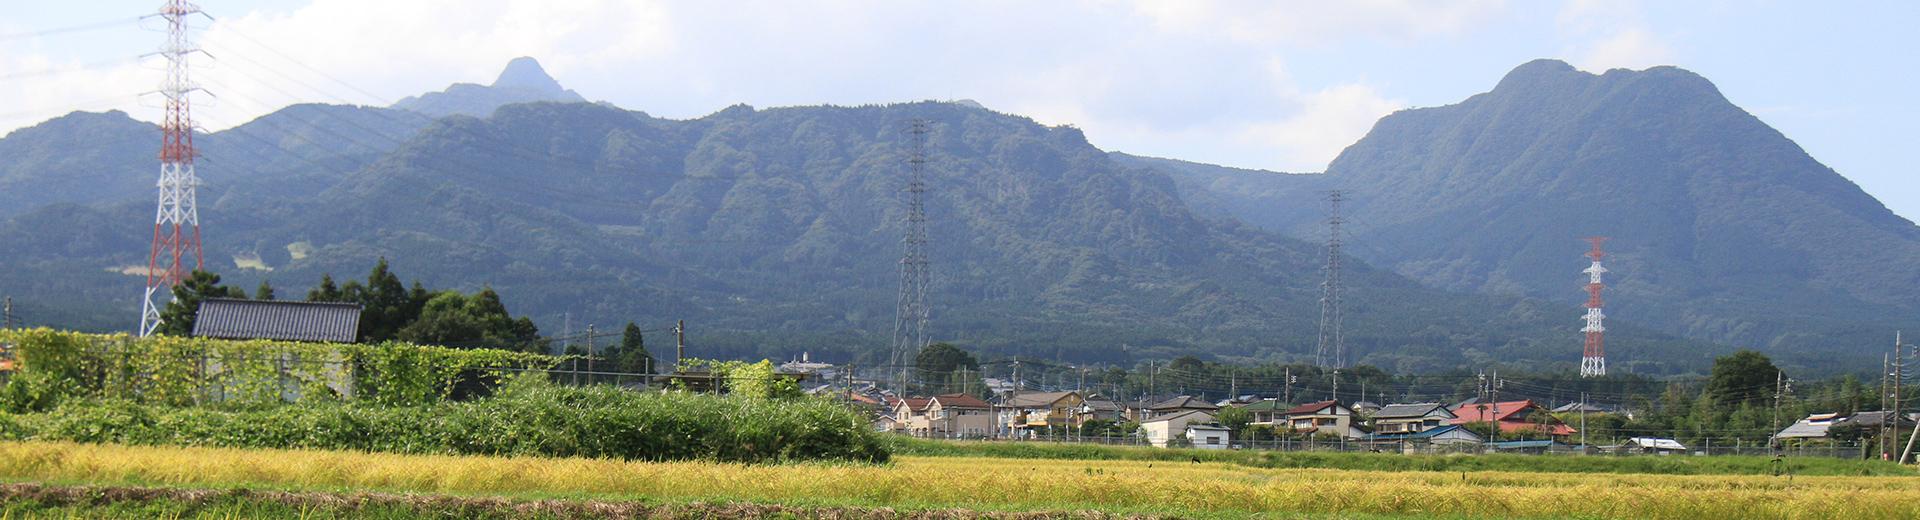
[138,0,202,336]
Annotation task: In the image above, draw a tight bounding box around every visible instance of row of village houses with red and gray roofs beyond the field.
[847,383,1920,457]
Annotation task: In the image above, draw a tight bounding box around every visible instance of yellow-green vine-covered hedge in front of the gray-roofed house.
[0,328,561,413]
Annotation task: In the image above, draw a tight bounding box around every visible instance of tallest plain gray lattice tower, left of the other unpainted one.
[893,119,931,390]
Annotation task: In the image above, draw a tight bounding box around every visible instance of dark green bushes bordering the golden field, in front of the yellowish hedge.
[0,374,889,462]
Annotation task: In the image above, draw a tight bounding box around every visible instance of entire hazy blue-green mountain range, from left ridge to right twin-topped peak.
[0,59,1889,372]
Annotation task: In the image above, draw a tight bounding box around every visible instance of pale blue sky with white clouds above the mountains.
[0,0,1920,219]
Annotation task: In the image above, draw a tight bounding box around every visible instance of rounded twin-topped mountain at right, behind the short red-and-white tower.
[1152,59,1920,370]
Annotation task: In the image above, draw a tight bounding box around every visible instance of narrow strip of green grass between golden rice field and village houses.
[887,436,1920,476]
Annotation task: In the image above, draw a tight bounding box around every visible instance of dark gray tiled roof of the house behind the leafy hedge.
[194,297,361,343]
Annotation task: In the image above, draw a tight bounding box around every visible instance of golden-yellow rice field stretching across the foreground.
[0,441,1920,520]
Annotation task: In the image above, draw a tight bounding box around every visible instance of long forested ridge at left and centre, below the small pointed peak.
[0,57,1758,374]
